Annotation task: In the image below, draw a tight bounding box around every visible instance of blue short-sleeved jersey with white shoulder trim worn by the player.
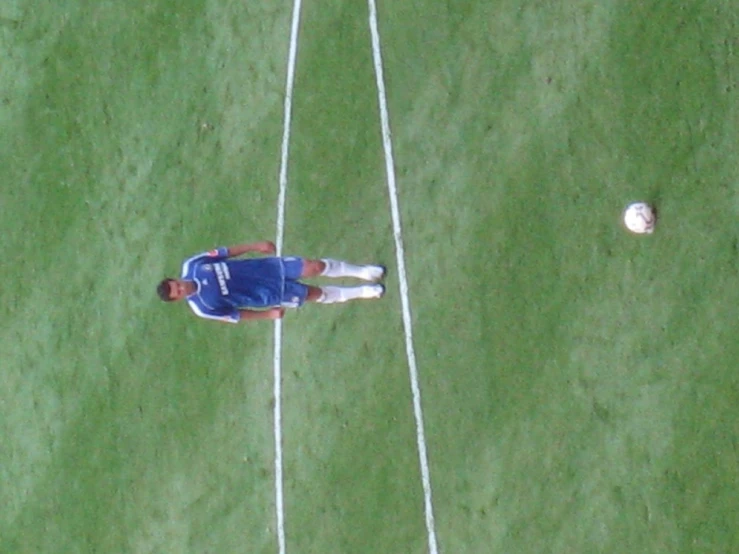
[181,247,285,323]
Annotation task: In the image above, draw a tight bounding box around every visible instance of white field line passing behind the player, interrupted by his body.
[273,0,302,554]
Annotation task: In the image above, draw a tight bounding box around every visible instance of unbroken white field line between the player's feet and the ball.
[368,0,438,554]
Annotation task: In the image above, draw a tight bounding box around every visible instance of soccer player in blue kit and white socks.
[157,241,385,323]
